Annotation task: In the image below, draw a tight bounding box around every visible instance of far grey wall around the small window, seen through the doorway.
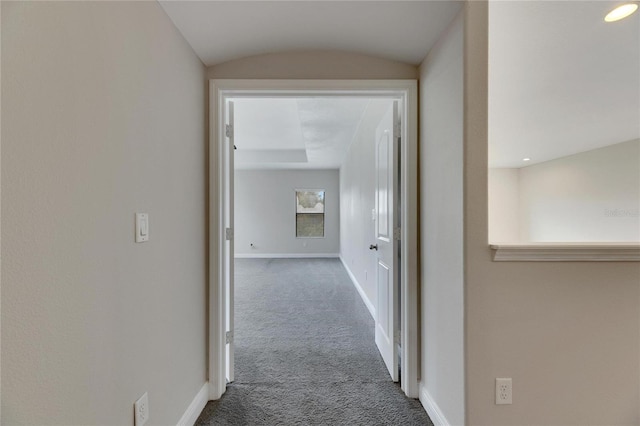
[234,170,340,256]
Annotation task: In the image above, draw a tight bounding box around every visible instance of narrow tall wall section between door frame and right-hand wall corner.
[420,9,465,425]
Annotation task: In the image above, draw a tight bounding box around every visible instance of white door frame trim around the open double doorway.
[208,79,420,400]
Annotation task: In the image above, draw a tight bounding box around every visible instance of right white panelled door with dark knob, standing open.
[369,102,400,382]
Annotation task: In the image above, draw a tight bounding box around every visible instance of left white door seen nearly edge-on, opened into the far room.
[223,101,235,383]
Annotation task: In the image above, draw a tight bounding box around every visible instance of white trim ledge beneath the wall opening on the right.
[490,243,640,262]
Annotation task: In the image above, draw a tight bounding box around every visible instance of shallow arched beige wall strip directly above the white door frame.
[208,51,418,80]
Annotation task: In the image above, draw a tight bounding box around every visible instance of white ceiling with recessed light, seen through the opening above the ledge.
[489,0,640,167]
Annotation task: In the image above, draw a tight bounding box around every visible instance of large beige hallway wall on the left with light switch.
[1,2,207,425]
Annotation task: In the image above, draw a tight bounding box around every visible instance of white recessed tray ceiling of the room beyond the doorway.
[233,97,369,169]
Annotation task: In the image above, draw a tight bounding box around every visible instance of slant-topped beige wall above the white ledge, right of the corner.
[518,139,640,242]
